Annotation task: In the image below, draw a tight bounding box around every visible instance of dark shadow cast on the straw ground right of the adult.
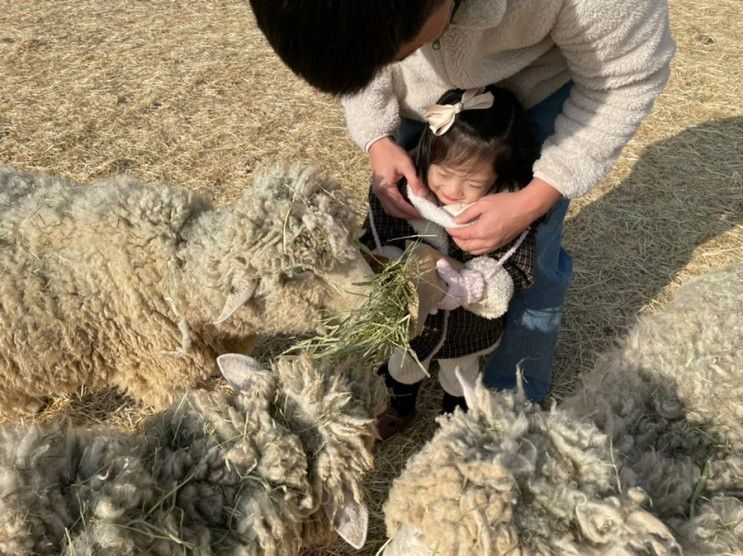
[553,117,743,398]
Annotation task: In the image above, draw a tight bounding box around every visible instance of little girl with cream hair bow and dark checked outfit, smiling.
[362,86,536,438]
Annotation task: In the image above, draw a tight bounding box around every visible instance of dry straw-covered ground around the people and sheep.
[0,0,743,554]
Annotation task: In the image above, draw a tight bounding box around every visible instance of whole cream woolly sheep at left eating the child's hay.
[0,165,371,412]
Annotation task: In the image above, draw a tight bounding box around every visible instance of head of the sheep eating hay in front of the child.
[204,165,372,335]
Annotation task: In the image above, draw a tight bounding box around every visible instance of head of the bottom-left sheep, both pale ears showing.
[212,354,386,548]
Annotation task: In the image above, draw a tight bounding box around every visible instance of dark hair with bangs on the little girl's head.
[415,85,538,193]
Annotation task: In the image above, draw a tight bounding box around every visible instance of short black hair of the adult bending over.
[250,0,445,94]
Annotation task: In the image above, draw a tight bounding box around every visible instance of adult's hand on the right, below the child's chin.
[446,178,560,255]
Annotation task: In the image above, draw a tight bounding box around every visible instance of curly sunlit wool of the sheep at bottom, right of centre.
[384,384,678,556]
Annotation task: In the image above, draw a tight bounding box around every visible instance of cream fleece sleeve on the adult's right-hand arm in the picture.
[534,0,675,198]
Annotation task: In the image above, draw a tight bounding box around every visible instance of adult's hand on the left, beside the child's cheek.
[369,137,424,218]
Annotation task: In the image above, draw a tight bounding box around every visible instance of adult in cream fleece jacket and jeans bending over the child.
[250,0,674,401]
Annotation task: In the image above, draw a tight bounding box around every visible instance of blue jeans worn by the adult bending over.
[397,83,573,402]
